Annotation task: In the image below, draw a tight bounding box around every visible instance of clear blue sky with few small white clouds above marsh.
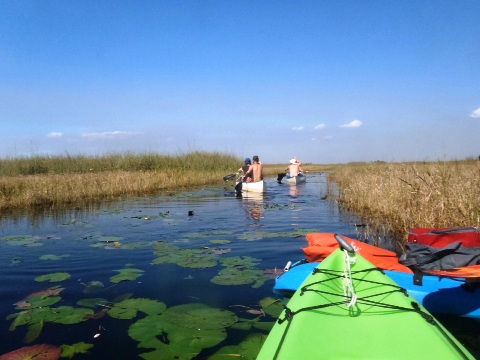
[0,0,480,163]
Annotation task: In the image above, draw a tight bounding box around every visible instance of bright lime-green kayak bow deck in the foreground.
[257,249,474,360]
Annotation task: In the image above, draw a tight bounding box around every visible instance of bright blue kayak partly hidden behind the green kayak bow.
[273,261,480,318]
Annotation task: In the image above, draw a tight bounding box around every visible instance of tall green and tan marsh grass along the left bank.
[0,152,241,209]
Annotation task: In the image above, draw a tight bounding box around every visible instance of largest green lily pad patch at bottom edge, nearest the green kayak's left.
[128,303,238,360]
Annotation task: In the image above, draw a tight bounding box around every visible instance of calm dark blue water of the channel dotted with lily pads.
[0,174,480,359]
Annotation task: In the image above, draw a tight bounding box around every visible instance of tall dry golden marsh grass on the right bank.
[329,161,480,241]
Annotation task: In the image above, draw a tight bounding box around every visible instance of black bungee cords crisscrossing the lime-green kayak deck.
[273,268,469,359]
